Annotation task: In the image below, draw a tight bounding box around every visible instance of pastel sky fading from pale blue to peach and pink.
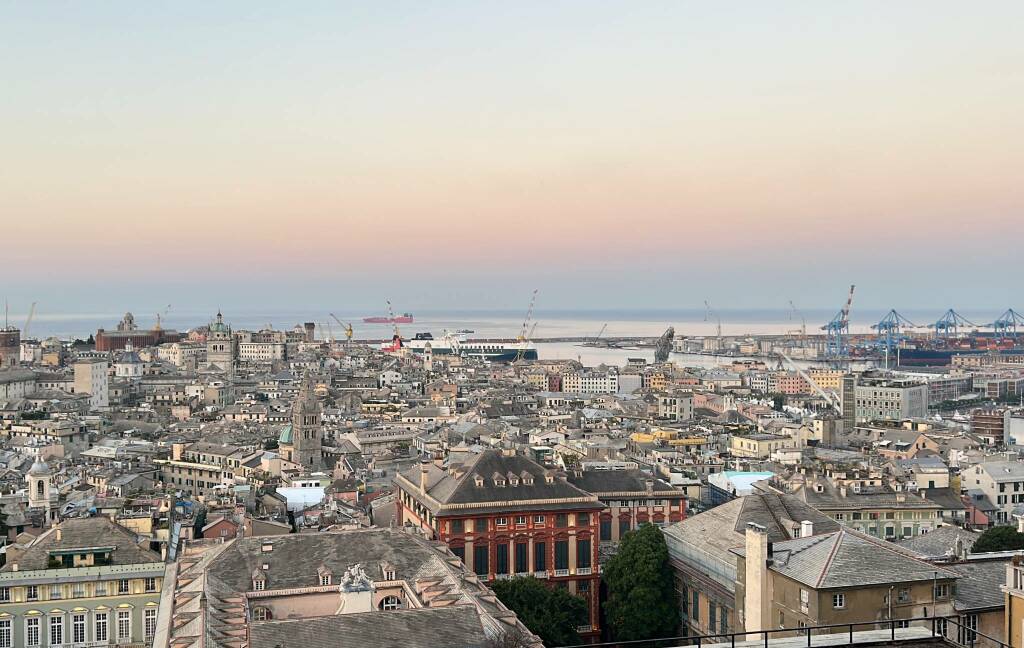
[0,0,1024,312]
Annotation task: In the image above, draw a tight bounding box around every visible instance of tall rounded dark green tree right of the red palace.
[604,524,679,641]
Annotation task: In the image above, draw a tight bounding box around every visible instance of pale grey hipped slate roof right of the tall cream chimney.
[732,527,958,590]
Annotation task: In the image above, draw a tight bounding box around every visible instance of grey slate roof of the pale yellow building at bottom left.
[0,517,163,571]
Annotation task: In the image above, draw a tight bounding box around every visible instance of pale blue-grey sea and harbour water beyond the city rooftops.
[16,308,1001,366]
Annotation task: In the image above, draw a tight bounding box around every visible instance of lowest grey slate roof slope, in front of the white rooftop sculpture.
[249,605,487,648]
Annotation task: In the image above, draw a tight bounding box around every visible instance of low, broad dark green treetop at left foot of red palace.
[490,576,596,646]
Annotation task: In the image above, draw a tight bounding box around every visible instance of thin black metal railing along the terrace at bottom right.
[561,616,1011,648]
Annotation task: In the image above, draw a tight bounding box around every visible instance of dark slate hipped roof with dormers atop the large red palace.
[401,450,603,514]
